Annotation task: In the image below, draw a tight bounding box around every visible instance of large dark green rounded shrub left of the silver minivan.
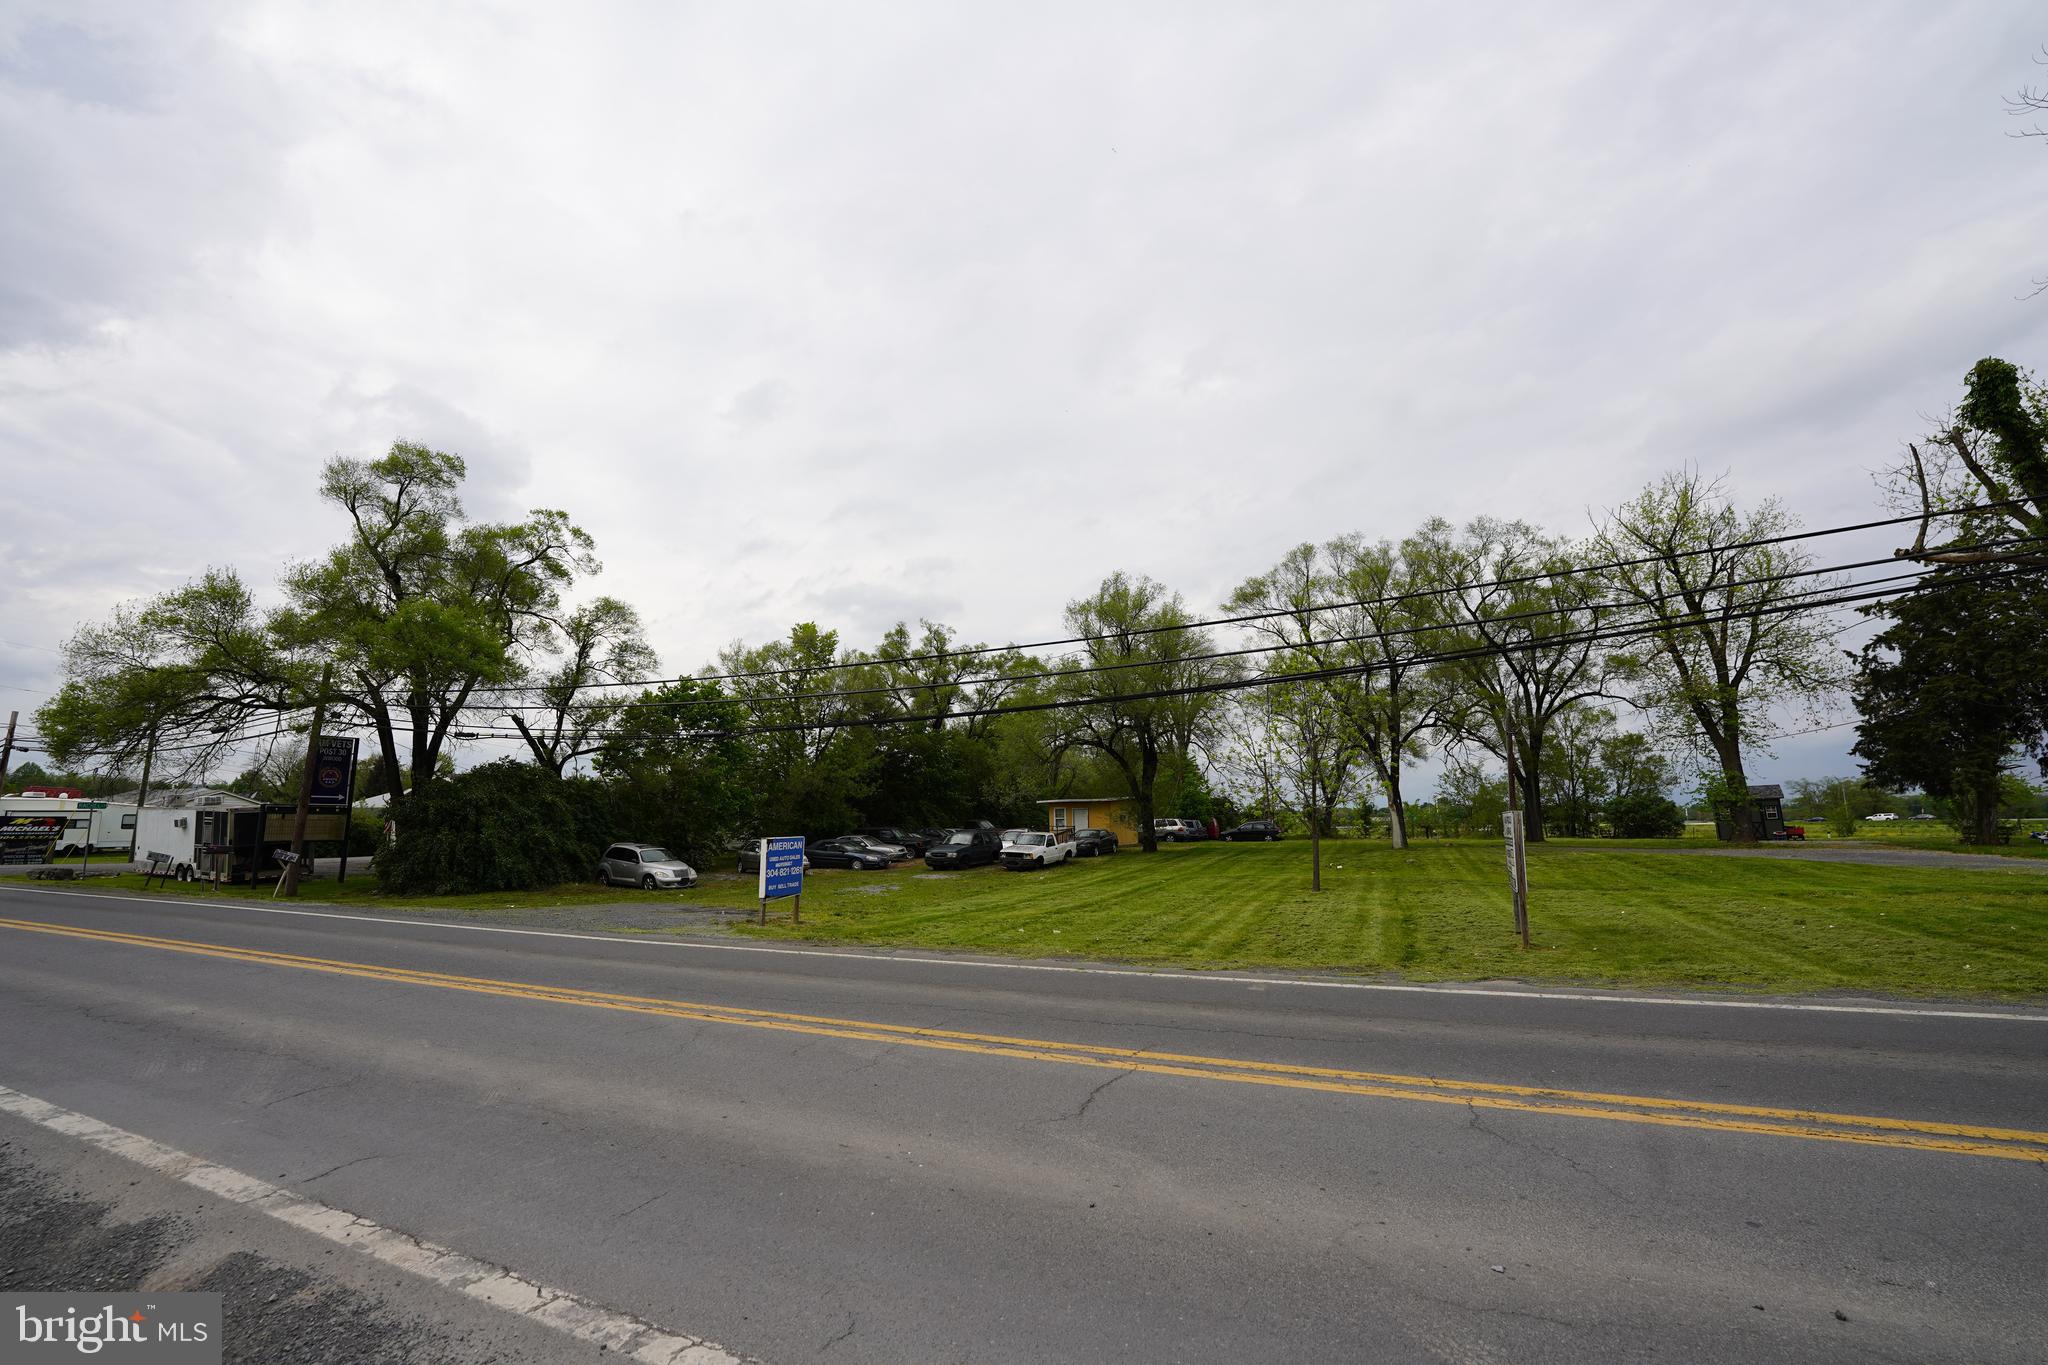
[377,759,604,894]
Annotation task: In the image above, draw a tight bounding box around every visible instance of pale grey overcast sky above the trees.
[0,0,2048,778]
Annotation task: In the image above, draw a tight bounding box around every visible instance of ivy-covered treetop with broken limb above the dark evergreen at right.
[1886,356,2048,569]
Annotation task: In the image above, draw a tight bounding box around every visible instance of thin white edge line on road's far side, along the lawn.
[4,886,2048,1023]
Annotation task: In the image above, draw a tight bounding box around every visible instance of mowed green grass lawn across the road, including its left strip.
[44,839,2048,999]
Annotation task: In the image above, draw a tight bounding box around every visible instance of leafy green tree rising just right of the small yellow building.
[1057,573,1223,853]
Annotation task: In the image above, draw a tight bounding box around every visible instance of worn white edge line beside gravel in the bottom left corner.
[0,1085,741,1365]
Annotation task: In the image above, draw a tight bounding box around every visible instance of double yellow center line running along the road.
[0,917,2048,1162]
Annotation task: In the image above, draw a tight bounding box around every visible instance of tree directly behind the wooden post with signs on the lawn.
[1401,518,1608,839]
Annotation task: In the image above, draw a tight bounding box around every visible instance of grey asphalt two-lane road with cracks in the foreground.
[0,886,2048,1361]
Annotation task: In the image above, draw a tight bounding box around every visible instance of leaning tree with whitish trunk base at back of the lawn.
[1225,536,1440,849]
